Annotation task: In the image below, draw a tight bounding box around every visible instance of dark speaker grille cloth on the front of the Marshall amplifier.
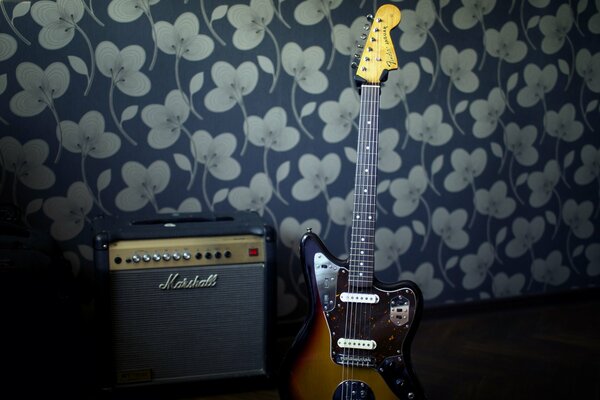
[111,264,266,382]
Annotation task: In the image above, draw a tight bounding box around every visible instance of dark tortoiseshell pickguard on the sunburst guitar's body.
[312,252,418,398]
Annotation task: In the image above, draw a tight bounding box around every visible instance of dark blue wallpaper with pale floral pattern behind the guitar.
[0,0,600,321]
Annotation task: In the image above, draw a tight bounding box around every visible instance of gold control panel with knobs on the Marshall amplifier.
[108,235,266,271]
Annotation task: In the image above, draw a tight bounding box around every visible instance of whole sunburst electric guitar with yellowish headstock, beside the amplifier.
[280,5,425,400]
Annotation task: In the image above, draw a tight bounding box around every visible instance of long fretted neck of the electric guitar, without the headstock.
[348,84,380,291]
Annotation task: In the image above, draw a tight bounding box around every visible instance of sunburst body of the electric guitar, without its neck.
[280,233,425,400]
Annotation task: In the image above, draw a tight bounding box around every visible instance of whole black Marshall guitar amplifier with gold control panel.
[94,212,276,389]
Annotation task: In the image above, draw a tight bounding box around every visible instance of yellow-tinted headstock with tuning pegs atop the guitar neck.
[354,4,400,84]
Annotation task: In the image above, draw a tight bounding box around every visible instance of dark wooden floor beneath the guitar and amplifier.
[193,290,600,400]
